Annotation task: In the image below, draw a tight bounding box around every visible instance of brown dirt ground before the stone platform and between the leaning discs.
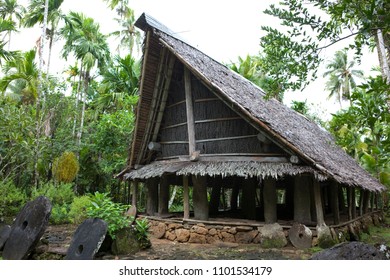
[32,225,311,260]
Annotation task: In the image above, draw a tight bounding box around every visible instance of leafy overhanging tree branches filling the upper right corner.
[260,0,390,94]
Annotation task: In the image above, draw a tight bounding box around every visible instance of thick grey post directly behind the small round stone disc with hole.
[294,175,312,224]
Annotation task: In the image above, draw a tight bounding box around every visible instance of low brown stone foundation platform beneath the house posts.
[146,211,383,248]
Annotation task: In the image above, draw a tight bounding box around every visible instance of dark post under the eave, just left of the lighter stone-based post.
[241,178,257,220]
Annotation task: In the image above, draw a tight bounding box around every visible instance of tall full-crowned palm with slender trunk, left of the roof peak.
[60,12,109,146]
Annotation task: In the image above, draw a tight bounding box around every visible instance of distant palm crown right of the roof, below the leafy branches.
[323,50,364,108]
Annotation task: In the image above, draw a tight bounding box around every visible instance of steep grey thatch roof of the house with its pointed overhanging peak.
[123,14,385,191]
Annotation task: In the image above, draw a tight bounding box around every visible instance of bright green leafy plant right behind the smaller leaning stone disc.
[87,192,130,239]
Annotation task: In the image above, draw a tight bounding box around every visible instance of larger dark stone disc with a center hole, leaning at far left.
[3,196,51,260]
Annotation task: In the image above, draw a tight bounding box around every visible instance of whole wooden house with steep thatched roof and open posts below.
[121,14,384,236]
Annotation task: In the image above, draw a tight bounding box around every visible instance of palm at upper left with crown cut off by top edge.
[23,0,64,73]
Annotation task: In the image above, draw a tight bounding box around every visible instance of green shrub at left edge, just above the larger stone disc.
[0,180,27,218]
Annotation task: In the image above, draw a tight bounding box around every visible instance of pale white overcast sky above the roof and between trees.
[13,0,378,118]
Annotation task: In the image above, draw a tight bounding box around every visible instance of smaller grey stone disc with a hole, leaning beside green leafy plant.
[65,218,107,260]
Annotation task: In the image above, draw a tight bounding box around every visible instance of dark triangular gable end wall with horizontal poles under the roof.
[143,58,288,164]
